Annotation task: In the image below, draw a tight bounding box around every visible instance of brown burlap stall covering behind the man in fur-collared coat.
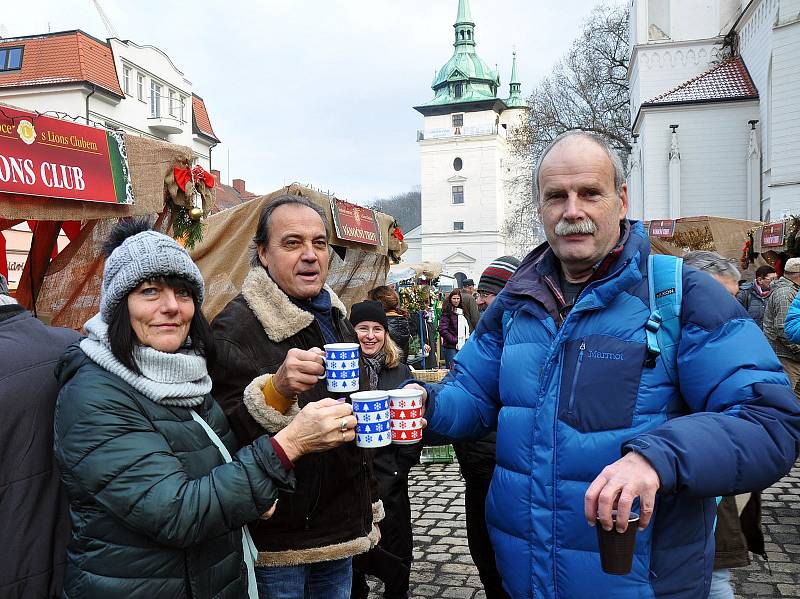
[190,184,403,320]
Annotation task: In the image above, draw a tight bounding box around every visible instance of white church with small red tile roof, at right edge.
[628,0,800,221]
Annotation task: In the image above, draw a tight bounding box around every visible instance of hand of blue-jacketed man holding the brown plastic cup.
[584,452,661,532]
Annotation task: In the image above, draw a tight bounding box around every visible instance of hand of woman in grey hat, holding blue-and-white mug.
[275,397,356,461]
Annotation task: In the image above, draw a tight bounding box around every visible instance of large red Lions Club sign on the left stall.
[0,106,133,209]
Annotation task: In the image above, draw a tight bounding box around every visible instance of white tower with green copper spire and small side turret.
[414,0,527,283]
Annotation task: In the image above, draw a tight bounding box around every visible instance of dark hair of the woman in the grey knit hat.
[108,276,216,374]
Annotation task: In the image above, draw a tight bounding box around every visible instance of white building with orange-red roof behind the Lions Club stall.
[0,30,220,170]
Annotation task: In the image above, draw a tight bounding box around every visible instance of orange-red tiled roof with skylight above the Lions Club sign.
[0,31,124,98]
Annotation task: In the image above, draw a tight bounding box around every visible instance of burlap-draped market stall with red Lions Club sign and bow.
[0,105,213,329]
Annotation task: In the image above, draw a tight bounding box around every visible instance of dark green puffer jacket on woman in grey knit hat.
[55,345,295,599]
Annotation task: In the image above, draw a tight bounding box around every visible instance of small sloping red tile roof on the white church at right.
[645,57,758,105]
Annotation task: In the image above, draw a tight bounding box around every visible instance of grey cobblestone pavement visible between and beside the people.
[370,462,800,599]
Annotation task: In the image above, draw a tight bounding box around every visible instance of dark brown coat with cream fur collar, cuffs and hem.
[211,267,381,566]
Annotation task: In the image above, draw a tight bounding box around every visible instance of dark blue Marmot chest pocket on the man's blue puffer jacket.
[558,335,647,433]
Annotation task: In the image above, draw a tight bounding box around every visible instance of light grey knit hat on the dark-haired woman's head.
[100,231,205,324]
